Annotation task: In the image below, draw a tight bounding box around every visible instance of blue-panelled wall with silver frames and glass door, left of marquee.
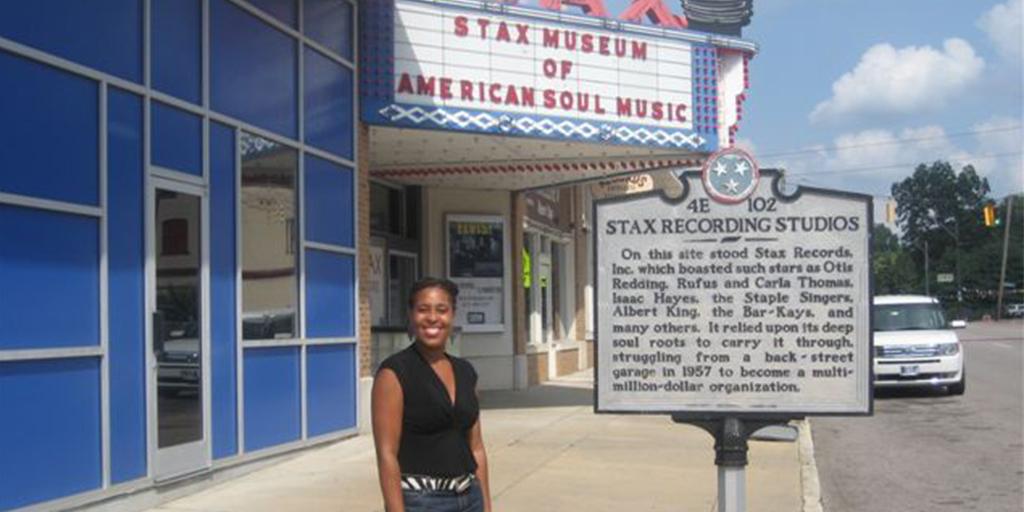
[0,0,359,510]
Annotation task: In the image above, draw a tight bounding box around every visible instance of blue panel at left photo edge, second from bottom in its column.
[0,205,99,349]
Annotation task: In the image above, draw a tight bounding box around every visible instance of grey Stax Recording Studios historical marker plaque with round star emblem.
[594,150,871,417]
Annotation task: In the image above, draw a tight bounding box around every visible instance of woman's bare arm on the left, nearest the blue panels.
[372,368,406,512]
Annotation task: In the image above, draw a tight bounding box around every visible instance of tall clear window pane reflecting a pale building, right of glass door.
[241,133,299,340]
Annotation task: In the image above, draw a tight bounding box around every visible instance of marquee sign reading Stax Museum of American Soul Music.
[361,0,753,152]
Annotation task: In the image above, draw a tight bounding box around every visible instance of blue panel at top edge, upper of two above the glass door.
[151,0,203,104]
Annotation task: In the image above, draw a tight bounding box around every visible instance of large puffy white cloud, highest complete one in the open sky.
[810,38,985,122]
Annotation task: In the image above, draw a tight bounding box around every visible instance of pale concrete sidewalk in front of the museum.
[154,371,806,512]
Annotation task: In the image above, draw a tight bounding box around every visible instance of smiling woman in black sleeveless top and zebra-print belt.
[373,278,490,512]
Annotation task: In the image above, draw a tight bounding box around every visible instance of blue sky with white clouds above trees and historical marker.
[520,0,1024,205]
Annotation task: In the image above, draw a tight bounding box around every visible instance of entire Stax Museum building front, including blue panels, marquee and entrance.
[0,0,756,510]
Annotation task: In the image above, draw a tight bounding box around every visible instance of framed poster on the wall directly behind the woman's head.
[444,211,506,333]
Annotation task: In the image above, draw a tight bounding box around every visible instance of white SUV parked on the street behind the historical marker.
[873,295,967,394]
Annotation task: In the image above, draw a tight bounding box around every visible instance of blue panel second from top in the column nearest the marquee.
[304,48,354,160]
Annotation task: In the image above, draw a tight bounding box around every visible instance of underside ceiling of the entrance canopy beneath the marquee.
[369,126,706,190]
